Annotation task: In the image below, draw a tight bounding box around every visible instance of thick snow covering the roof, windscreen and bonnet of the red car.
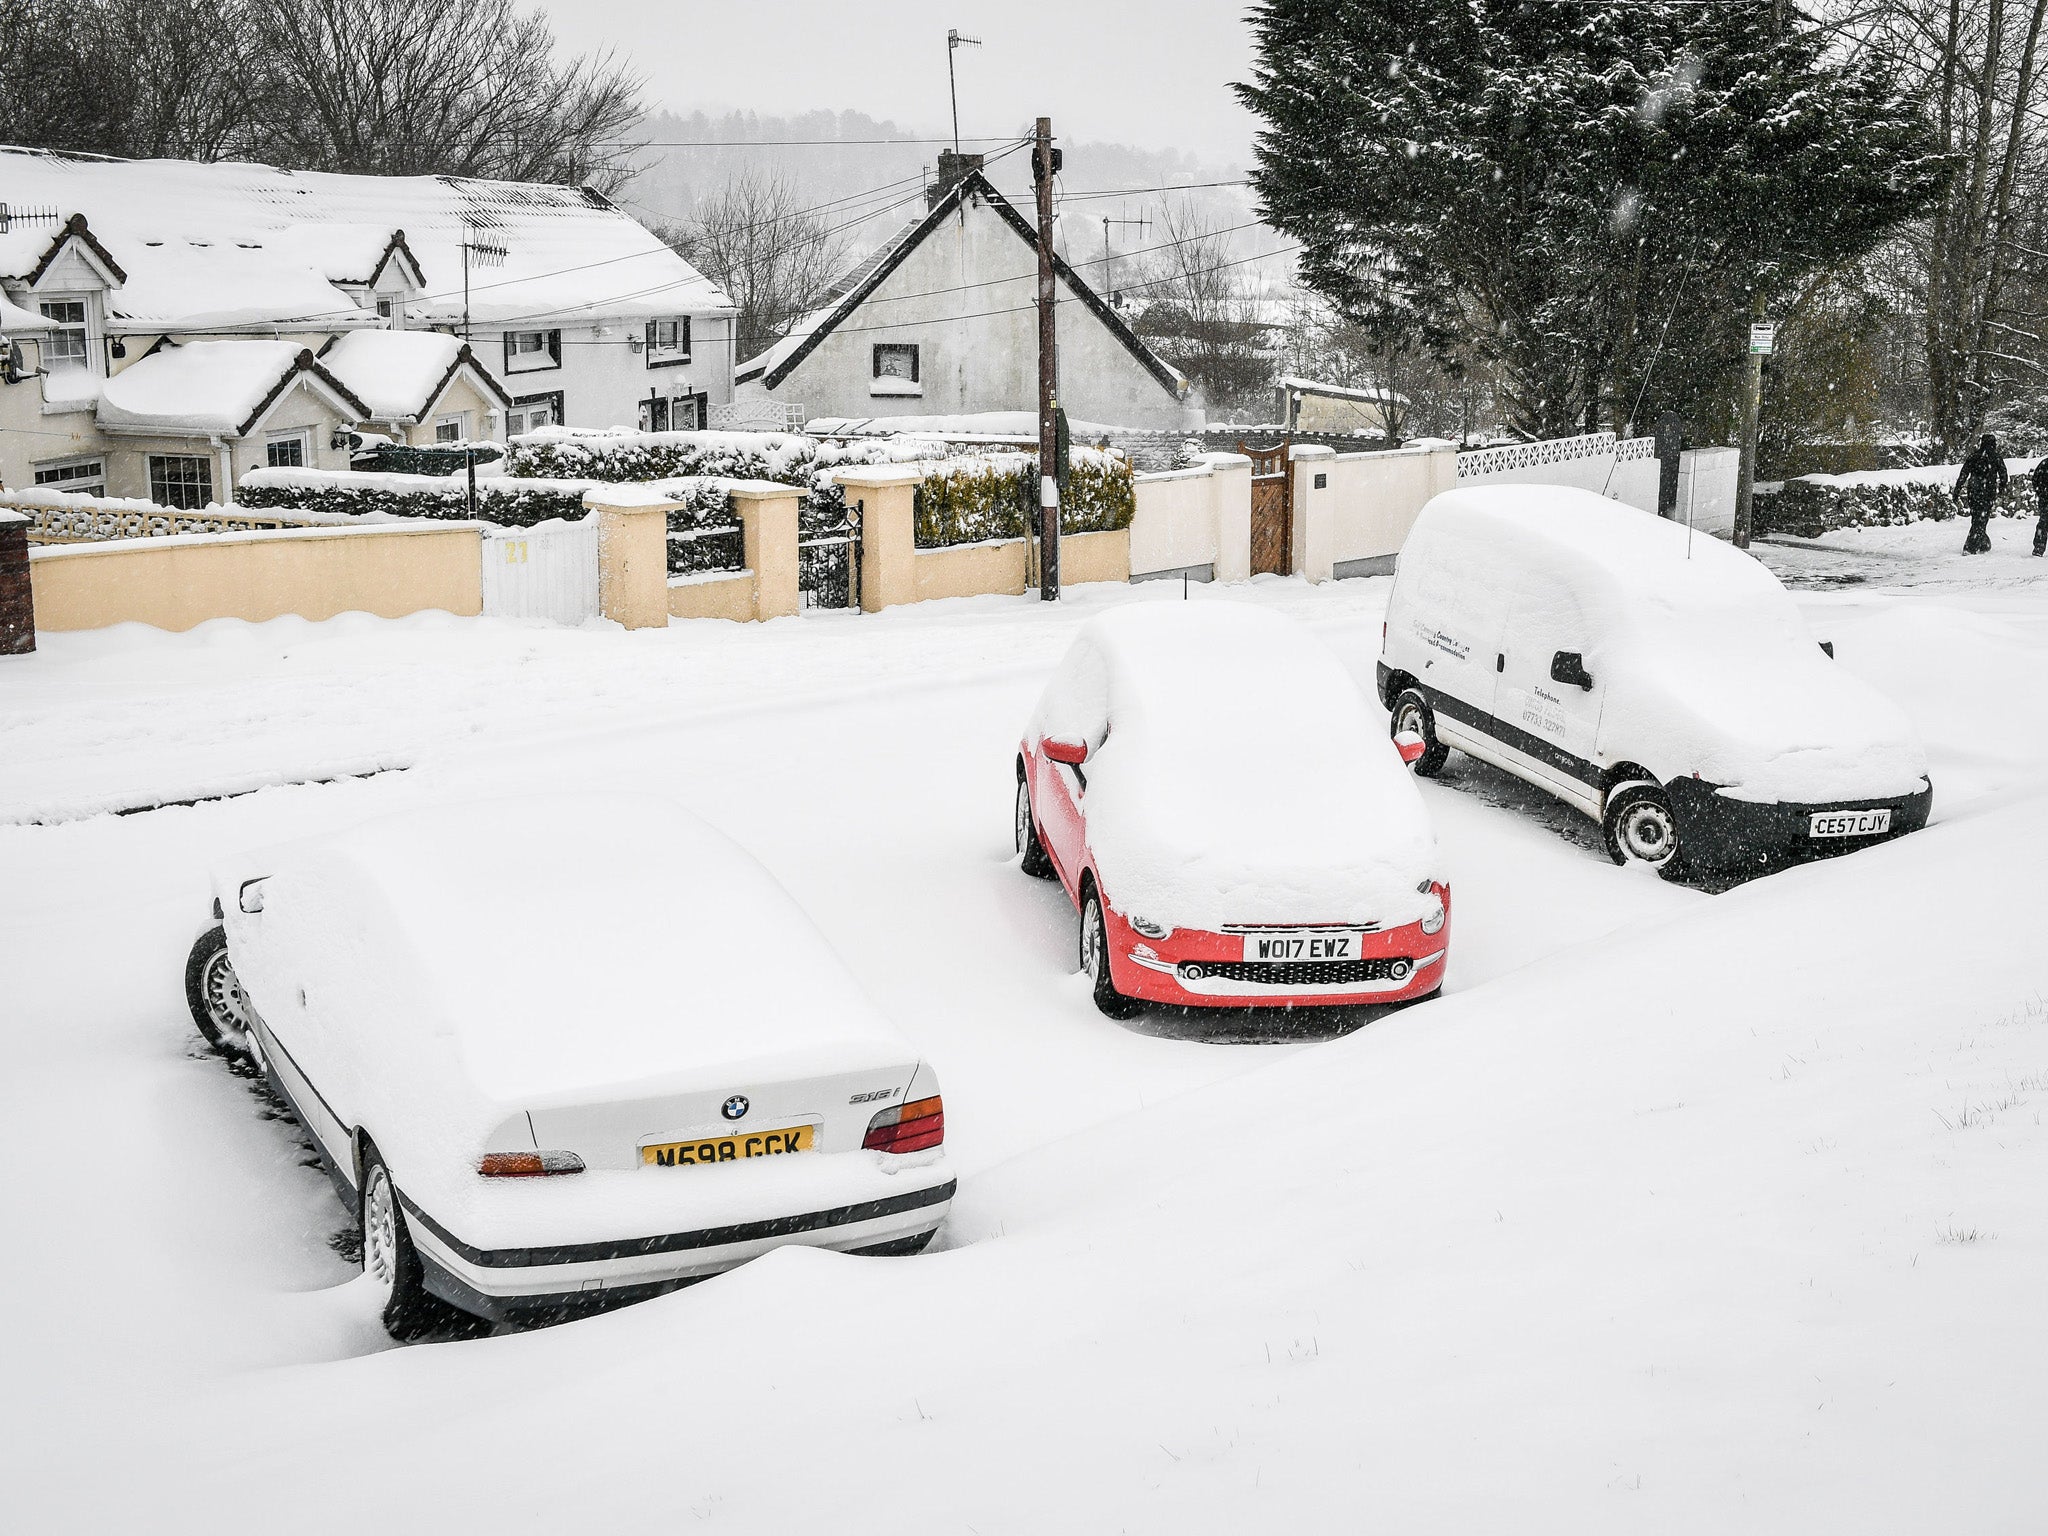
[1032,598,1440,930]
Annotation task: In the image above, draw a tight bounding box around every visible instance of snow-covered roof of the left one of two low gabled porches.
[97,338,371,436]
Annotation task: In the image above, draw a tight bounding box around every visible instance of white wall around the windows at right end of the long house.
[469,315,733,436]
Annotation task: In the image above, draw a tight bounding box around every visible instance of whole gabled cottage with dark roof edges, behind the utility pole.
[737,170,1200,430]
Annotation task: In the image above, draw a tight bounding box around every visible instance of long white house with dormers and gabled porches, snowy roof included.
[0,150,735,506]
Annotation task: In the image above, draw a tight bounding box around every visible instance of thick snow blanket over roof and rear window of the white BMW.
[215,795,915,1126]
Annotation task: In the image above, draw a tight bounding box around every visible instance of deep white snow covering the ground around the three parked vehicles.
[0,540,2048,1532]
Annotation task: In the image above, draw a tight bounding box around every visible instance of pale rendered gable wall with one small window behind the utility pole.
[768,195,1184,428]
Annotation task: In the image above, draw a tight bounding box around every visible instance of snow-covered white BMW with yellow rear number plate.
[186,797,954,1337]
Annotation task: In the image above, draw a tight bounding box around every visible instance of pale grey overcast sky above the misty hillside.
[532,0,1253,164]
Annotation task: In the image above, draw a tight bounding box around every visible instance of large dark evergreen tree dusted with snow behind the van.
[1237,0,1950,436]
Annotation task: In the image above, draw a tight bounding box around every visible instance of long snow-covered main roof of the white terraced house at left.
[0,150,731,332]
